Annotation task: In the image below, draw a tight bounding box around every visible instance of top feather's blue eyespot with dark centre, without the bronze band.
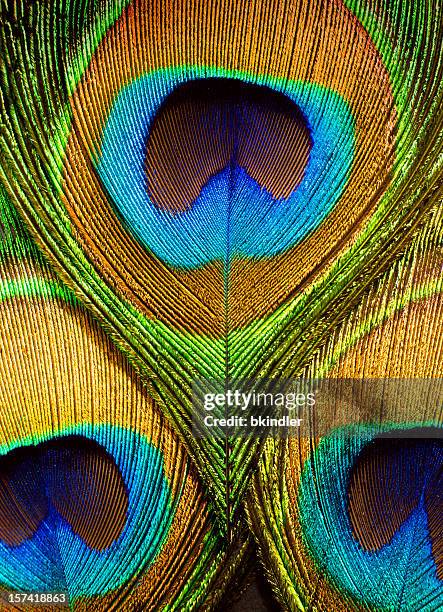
[93,70,354,268]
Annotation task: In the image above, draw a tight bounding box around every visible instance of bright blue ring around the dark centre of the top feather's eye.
[94,66,355,269]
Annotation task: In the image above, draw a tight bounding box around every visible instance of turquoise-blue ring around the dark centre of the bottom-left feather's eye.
[0,424,173,601]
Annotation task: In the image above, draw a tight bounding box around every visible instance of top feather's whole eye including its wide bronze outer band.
[63,2,397,335]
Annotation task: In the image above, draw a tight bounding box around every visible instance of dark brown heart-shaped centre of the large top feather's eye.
[146,79,312,213]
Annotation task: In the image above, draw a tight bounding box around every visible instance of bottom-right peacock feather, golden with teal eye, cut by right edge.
[247,206,443,612]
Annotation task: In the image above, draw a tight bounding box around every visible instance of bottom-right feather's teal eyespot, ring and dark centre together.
[299,425,443,610]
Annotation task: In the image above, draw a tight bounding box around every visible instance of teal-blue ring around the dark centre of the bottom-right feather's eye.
[298,423,443,610]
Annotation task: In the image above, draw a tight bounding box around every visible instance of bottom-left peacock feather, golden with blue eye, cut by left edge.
[0,192,248,610]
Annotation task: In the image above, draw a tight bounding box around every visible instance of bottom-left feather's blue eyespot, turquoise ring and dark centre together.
[0,425,172,600]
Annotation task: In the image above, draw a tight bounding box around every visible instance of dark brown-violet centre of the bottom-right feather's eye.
[348,428,443,580]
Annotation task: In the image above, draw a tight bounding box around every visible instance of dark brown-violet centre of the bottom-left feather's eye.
[0,436,128,550]
